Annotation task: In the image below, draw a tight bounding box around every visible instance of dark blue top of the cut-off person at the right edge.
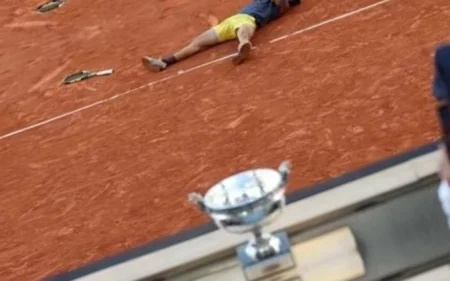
[433,45,450,102]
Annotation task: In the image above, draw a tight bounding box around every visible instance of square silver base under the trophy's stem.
[236,232,302,281]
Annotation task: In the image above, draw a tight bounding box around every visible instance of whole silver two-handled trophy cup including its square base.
[189,161,301,281]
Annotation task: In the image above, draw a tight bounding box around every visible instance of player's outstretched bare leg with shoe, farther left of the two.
[142,29,220,72]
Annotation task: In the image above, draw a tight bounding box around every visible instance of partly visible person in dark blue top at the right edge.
[433,45,450,228]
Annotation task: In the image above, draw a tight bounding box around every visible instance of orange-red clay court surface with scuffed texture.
[0,0,450,281]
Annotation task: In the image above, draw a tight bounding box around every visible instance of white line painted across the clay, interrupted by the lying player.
[0,0,393,140]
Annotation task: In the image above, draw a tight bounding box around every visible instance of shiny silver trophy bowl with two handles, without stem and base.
[189,161,290,235]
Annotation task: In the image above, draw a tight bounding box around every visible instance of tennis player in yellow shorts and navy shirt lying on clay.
[142,0,301,72]
